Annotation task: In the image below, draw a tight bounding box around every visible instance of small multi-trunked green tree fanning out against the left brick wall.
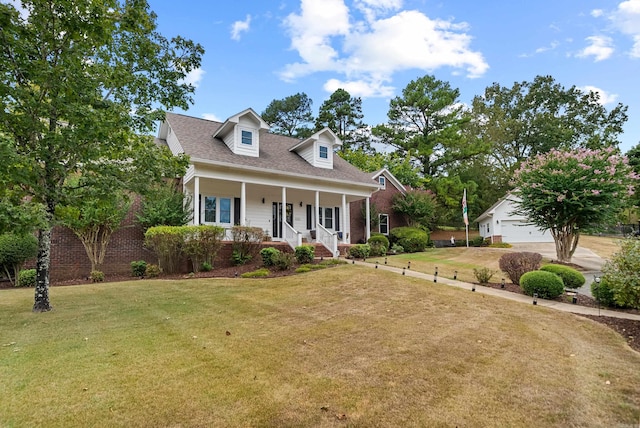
[56,187,131,272]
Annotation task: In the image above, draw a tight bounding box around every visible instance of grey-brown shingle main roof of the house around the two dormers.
[158,113,378,187]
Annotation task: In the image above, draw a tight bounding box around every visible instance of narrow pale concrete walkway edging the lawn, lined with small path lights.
[354,261,640,321]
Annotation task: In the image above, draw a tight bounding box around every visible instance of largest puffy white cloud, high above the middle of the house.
[281,0,489,97]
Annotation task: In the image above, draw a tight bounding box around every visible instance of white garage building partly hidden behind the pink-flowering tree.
[476,193,553,244]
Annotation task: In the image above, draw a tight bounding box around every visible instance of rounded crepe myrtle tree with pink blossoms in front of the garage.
[512,148,639,262]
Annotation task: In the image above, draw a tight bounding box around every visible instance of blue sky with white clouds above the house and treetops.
[149,0,640,151]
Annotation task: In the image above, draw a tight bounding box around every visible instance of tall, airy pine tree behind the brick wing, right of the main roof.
[372,75,483,177]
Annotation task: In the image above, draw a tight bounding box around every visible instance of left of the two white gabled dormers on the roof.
[213,108,269,157]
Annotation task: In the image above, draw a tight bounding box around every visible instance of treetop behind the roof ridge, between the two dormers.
[261,92,313,138]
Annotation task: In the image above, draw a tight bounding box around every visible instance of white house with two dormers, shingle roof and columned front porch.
[157,109,379,255]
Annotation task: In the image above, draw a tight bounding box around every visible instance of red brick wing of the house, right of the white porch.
[349,168,407,243]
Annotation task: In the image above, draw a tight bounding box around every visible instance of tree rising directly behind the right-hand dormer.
[316,89,371,152]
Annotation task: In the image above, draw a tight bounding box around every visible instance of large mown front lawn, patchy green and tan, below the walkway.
[0,265,640,427]
